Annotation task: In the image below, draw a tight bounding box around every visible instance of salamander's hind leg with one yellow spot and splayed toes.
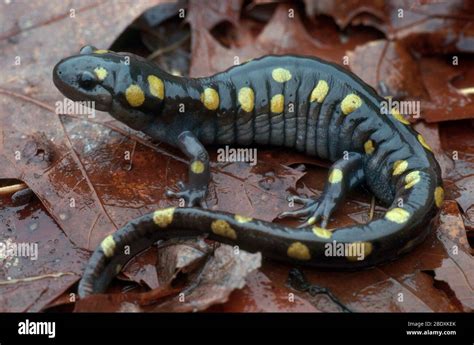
[279,152,365,228]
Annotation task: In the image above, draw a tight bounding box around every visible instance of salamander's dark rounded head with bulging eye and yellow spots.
[53,46,166,129]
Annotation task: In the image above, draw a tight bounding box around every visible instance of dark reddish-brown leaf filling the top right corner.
[304,0,474,53]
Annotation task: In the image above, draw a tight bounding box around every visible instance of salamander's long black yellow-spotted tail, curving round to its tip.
[79,169,443,297]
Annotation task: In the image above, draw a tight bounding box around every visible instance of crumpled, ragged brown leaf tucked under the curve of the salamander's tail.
[75,240,261,312]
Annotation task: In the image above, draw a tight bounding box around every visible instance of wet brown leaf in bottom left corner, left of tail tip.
[0,196,88,312]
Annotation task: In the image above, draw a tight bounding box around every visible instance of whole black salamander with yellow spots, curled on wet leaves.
[53,46,444,297]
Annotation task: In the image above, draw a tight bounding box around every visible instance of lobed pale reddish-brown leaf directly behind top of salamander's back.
[189,2,384,76]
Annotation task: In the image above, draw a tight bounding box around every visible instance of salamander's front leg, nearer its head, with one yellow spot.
[166,131,210,208]
